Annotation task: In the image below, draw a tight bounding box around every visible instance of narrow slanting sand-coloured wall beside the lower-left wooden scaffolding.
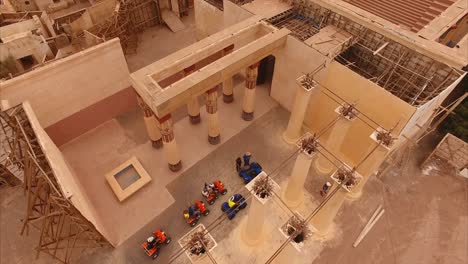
[23,102,113,243]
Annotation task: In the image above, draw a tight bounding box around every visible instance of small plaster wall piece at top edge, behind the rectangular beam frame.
[194,0,224,40]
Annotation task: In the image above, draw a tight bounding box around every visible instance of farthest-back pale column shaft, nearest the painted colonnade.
[283,78,316,144]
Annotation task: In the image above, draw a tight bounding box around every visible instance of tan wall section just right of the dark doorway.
[271,36,325,111]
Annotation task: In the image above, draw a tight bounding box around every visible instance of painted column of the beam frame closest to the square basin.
[158,114,182,172]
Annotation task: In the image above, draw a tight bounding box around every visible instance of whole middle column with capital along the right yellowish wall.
[315,105,357,174]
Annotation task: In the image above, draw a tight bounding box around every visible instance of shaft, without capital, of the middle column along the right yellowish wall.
[315,116,352,175]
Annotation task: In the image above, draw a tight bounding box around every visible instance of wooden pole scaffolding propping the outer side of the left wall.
[0,105,109,263]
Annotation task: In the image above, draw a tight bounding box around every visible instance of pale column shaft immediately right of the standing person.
[310,182,348,236]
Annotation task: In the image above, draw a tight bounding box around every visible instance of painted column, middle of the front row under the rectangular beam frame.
[206,85,221,145]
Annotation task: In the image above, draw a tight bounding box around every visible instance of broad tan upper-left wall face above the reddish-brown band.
[0,39,130,127]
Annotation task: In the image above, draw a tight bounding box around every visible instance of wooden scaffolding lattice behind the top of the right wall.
[267,0,462,106]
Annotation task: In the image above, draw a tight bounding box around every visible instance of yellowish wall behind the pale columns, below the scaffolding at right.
[304,62,416,175]
